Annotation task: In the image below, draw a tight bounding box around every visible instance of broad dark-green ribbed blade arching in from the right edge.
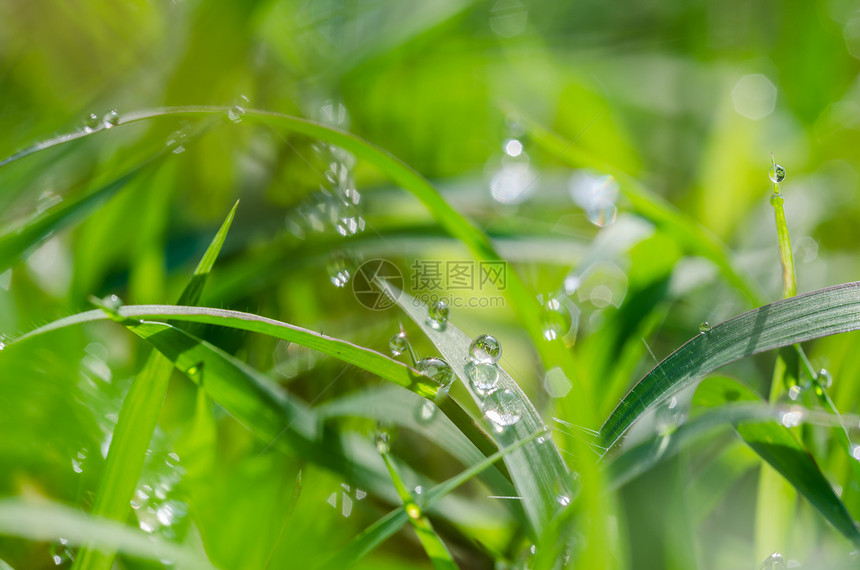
[600,282,860,448]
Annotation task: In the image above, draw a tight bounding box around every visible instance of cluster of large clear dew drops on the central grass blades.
[389,300,522,431]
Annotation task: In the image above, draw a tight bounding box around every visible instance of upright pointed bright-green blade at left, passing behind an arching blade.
[73,202,239,570]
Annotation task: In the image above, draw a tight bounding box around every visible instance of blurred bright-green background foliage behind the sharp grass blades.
[0,0,860,568]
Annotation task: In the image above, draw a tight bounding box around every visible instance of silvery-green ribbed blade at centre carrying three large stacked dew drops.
[378,281,573,535]
